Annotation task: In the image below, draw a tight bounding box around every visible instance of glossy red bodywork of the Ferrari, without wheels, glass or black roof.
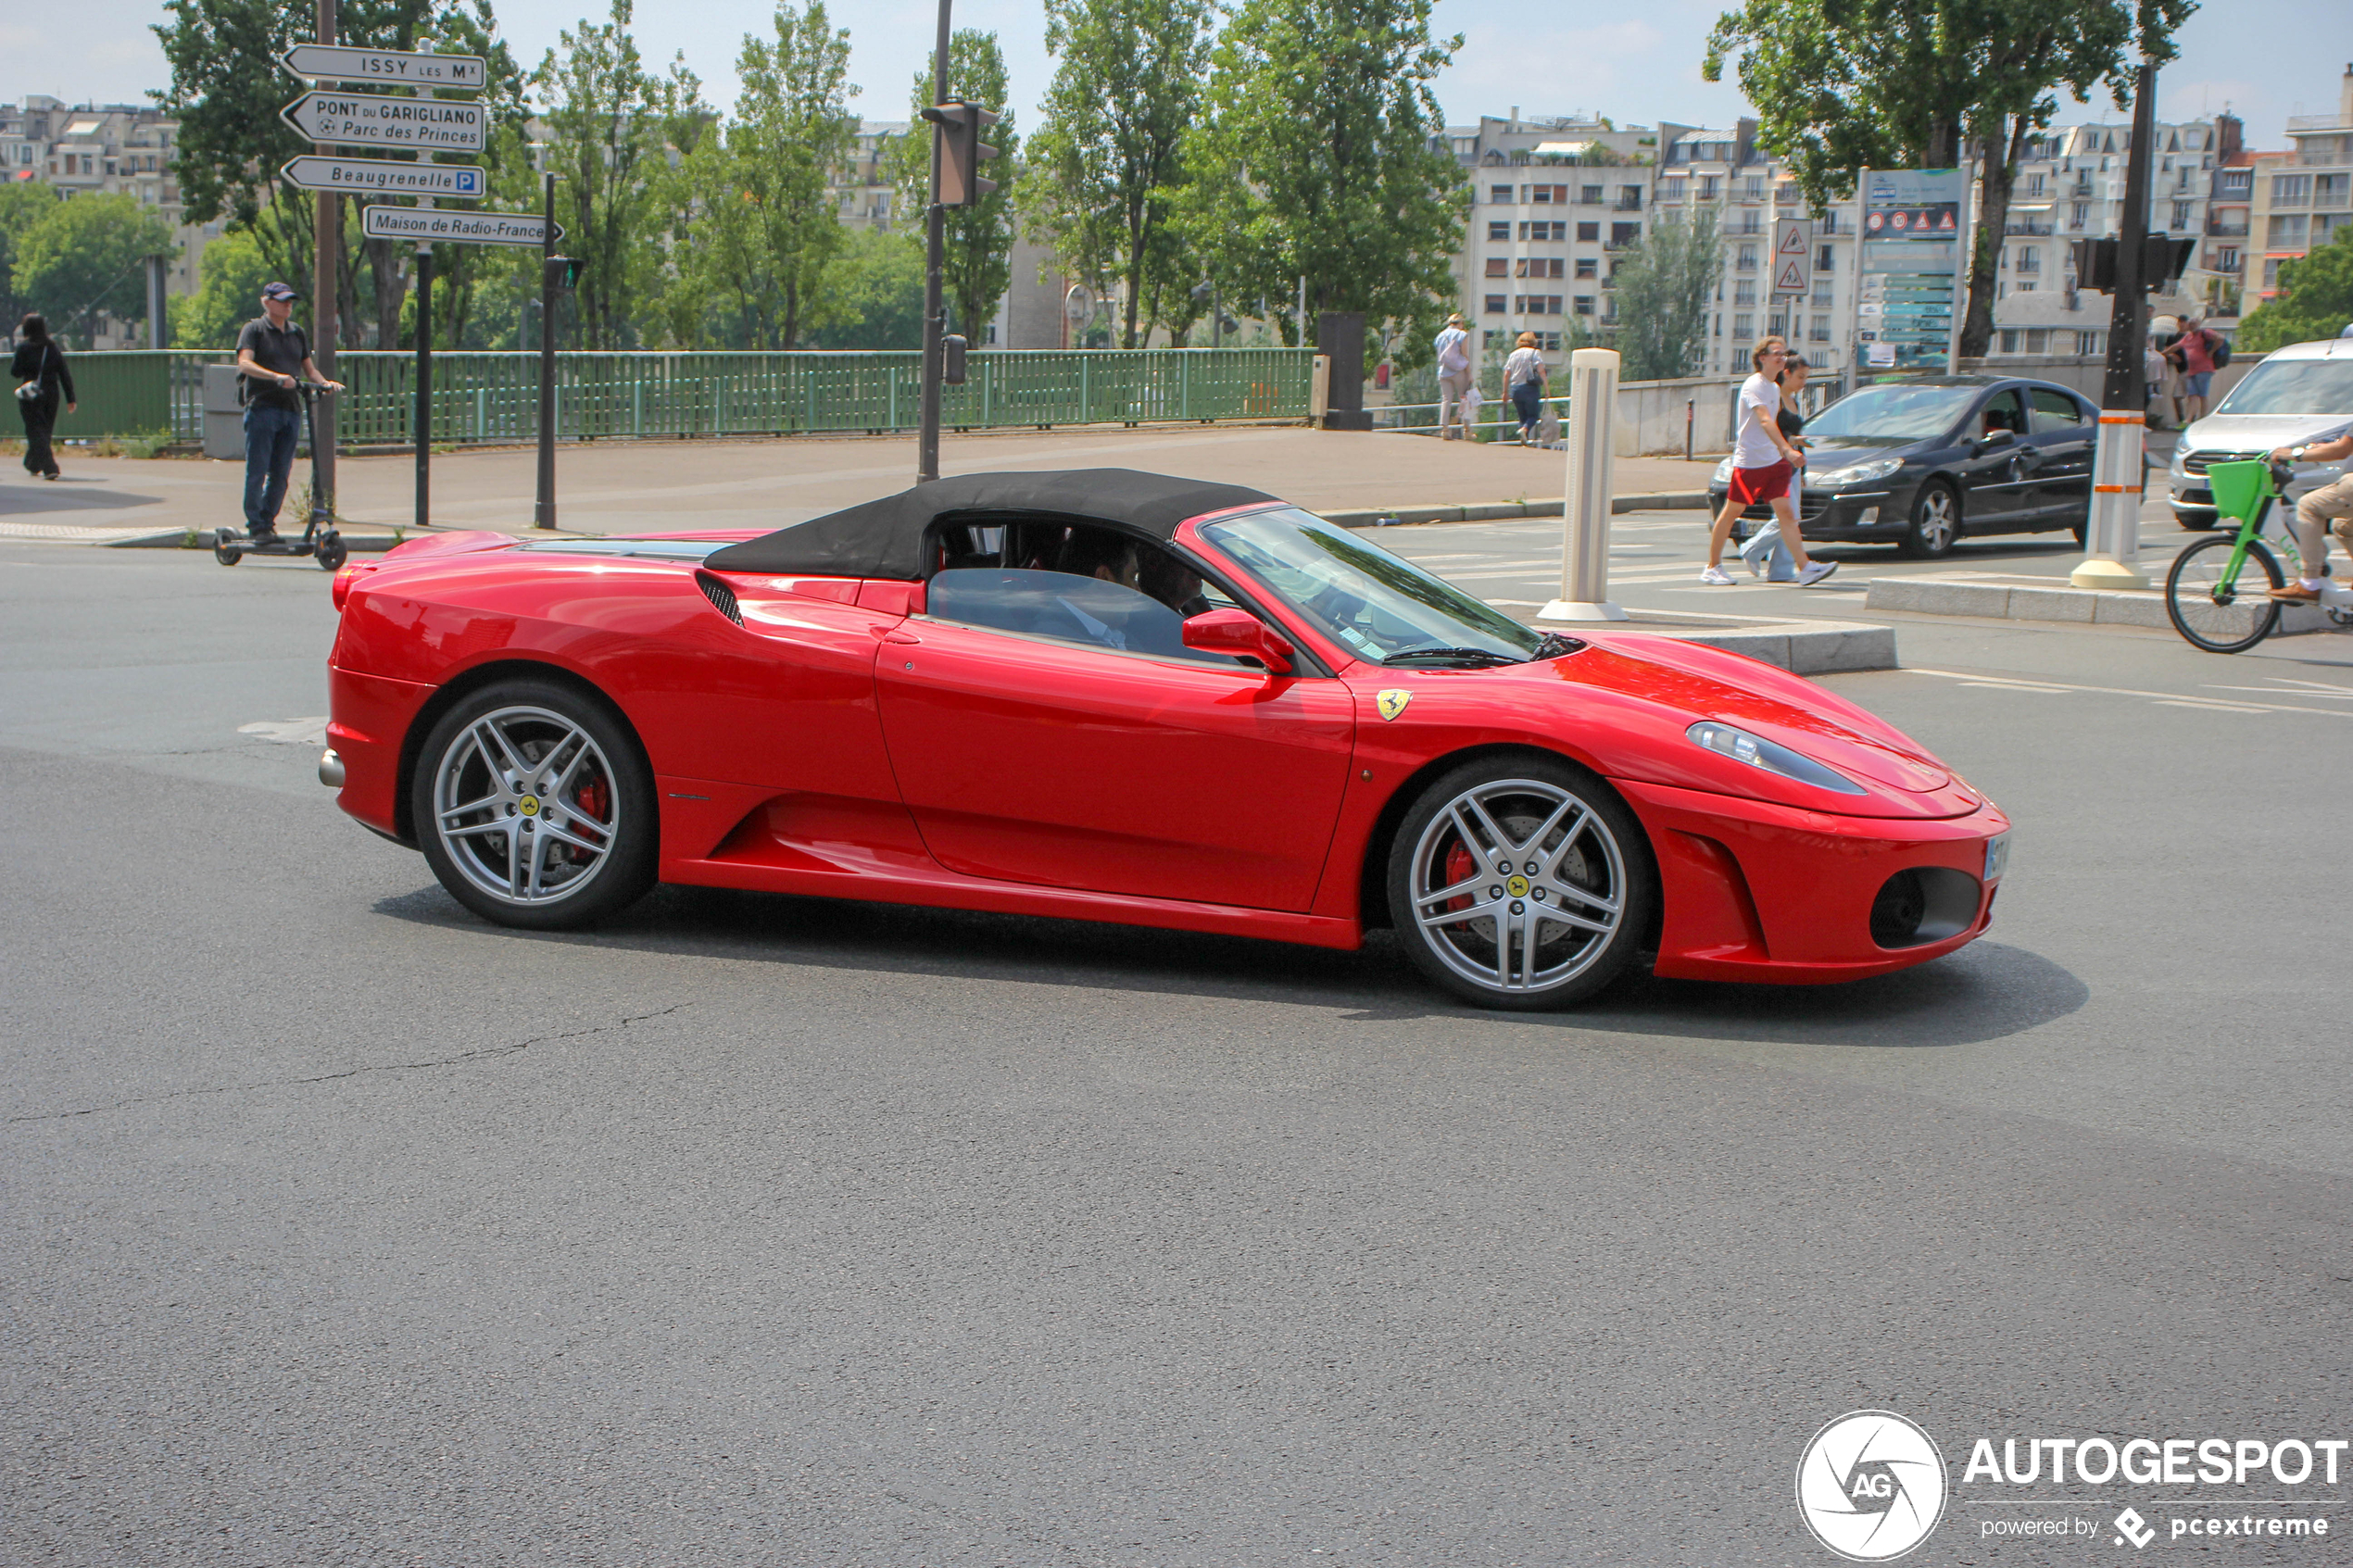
[330,520,2009,983]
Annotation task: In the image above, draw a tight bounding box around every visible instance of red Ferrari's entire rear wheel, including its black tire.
[409,680,661,931]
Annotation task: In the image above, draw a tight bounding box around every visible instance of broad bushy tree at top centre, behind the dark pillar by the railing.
[1179,0,1471,364]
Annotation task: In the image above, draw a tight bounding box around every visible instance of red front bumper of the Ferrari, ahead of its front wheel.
[1612,778,2009,985]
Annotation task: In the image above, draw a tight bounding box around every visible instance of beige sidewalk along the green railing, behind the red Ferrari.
[0,425,1716,543]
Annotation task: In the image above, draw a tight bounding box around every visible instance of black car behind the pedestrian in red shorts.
[1708,376,2099,558]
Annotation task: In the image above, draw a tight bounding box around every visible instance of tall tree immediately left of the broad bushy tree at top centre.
[1026,0,1210,348]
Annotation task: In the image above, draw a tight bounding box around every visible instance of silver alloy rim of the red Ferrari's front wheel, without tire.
[1409,778,1626,992]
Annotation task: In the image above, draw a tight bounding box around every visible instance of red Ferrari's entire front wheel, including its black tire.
[1389,755,1659,1010]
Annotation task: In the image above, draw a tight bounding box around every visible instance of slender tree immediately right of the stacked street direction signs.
[532,0,709,348]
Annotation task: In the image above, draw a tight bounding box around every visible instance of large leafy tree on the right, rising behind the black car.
[1701,0,2197,355]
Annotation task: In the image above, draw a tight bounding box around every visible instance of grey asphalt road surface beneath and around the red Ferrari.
[0,546,2353,1568]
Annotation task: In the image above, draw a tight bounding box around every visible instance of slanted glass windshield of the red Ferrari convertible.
[1202,506,1567,665]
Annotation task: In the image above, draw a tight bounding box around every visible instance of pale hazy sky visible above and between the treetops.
[0,0,2353,148]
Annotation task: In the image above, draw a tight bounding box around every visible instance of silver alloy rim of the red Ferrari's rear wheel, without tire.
[433,708,622,905]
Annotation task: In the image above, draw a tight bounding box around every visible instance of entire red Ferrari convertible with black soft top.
[320,470,2009,1009]
